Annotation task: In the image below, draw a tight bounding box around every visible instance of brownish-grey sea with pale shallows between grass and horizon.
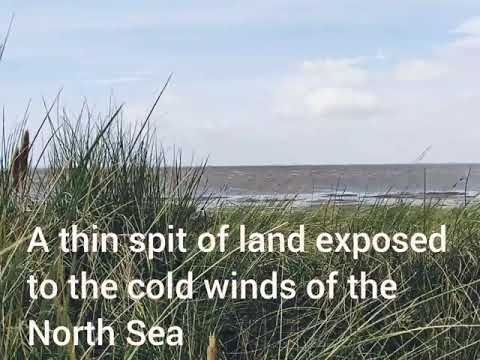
[202,164,480,206]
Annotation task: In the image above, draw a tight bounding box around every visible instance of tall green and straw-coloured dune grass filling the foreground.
[0,100,480,360]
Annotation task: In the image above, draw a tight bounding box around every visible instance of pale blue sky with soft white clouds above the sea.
[0,0,480,165]
